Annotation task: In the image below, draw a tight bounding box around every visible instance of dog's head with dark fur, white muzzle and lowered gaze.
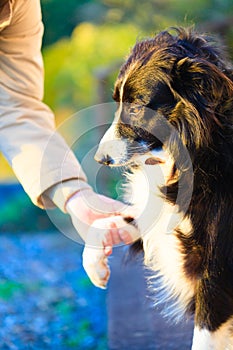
[96,28,233,172]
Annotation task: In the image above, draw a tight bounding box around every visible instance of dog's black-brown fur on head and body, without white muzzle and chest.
[113,28,233,331]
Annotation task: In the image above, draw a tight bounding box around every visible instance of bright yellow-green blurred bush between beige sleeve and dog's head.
[43,23,139,118]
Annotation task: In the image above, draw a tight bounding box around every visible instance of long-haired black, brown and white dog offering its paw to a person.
[83,28,233,350]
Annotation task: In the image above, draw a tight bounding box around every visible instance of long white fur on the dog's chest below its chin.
[125,158,195,319]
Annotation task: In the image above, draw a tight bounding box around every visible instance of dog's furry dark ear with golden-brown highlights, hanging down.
[171,57,233,148]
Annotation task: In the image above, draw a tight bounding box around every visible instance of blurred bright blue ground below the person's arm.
[0,233,107,350]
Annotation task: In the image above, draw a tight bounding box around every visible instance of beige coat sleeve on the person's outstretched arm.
[0,0,88,207]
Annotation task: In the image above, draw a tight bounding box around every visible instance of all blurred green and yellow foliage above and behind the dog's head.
[42,0,233,118]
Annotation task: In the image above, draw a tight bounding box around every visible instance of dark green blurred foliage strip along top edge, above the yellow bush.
[41,0,233,51]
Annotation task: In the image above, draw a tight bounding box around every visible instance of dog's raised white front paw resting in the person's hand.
[83,216,140,289]
